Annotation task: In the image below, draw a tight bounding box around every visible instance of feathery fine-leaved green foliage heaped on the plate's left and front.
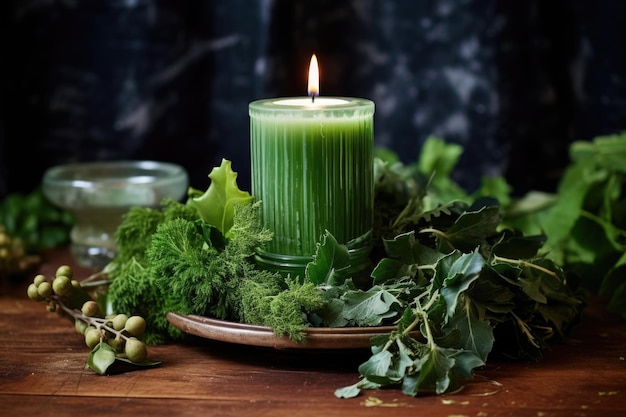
[109,202,324,344]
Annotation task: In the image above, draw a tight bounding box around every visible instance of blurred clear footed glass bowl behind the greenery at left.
[43,161,189,268]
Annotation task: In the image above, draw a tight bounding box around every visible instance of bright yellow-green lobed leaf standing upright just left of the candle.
[187,159,253,236]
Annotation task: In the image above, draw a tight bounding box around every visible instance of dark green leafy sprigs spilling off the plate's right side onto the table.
[325,138,585,398]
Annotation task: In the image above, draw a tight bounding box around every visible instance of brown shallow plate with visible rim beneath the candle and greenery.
[167,313,395,350]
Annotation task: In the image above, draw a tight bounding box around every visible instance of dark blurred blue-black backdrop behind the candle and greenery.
[0,0,626,197]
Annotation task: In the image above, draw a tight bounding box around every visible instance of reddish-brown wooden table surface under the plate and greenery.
[0,250,626,417]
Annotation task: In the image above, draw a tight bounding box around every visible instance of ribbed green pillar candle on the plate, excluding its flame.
[249,97,374,276]
